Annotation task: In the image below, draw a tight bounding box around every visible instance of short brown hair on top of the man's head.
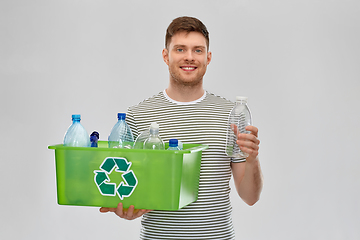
[165,16,209,50]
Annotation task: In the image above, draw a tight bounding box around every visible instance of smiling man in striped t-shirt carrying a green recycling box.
[100,17,262,239]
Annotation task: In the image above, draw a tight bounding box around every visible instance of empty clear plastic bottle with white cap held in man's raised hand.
[225,96,252,158]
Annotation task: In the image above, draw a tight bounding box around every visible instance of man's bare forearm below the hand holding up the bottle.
[232,158,263,206]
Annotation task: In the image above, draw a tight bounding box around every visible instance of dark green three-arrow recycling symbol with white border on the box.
[94,157,138,200]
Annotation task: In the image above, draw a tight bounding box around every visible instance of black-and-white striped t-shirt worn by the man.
[126,91,245,240]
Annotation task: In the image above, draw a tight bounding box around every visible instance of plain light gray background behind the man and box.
[0,0,360,240]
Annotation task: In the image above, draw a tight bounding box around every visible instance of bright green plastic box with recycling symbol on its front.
[48,141,208,210]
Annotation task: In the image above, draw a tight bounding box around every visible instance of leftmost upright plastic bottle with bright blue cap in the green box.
[64,114,90,147]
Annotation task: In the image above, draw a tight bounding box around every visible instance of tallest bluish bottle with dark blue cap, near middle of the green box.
[108,113,134,148]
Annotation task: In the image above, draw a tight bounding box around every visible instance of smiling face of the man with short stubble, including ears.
[163,32,211,86]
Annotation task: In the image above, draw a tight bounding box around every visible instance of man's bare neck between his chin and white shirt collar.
[165,82,204,102]
